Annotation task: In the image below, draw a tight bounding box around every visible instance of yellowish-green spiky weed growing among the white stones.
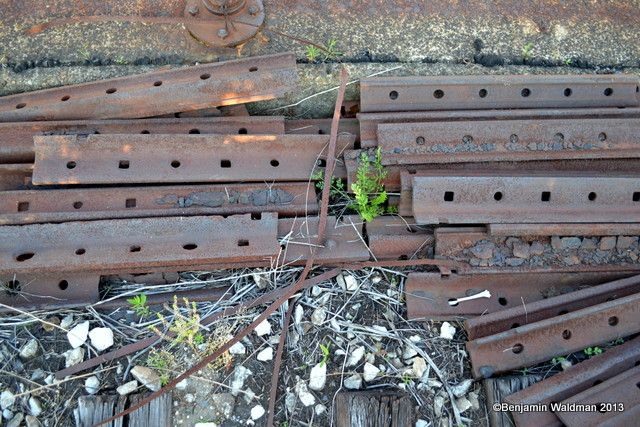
[151,295,204,350]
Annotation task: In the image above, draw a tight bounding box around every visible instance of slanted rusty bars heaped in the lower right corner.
[465,275,640,426]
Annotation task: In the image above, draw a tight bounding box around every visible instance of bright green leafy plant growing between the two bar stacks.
[350,147,387,222]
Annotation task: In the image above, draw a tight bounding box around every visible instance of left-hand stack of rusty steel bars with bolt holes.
[0,54,370,309]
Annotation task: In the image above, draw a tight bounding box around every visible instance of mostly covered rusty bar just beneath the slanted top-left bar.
[0,117,284,163]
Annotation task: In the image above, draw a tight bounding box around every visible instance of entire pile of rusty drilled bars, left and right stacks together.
[0,54,640,425]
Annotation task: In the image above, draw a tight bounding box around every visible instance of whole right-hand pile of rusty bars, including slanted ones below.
[358,76,640,426]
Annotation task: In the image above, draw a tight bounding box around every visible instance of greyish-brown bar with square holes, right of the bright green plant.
[412,172,640,224]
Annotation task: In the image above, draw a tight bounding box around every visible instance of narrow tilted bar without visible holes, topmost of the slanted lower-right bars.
[465,273,640,340]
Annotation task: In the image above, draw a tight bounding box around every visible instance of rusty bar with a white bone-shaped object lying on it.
[405,271,640,320]
